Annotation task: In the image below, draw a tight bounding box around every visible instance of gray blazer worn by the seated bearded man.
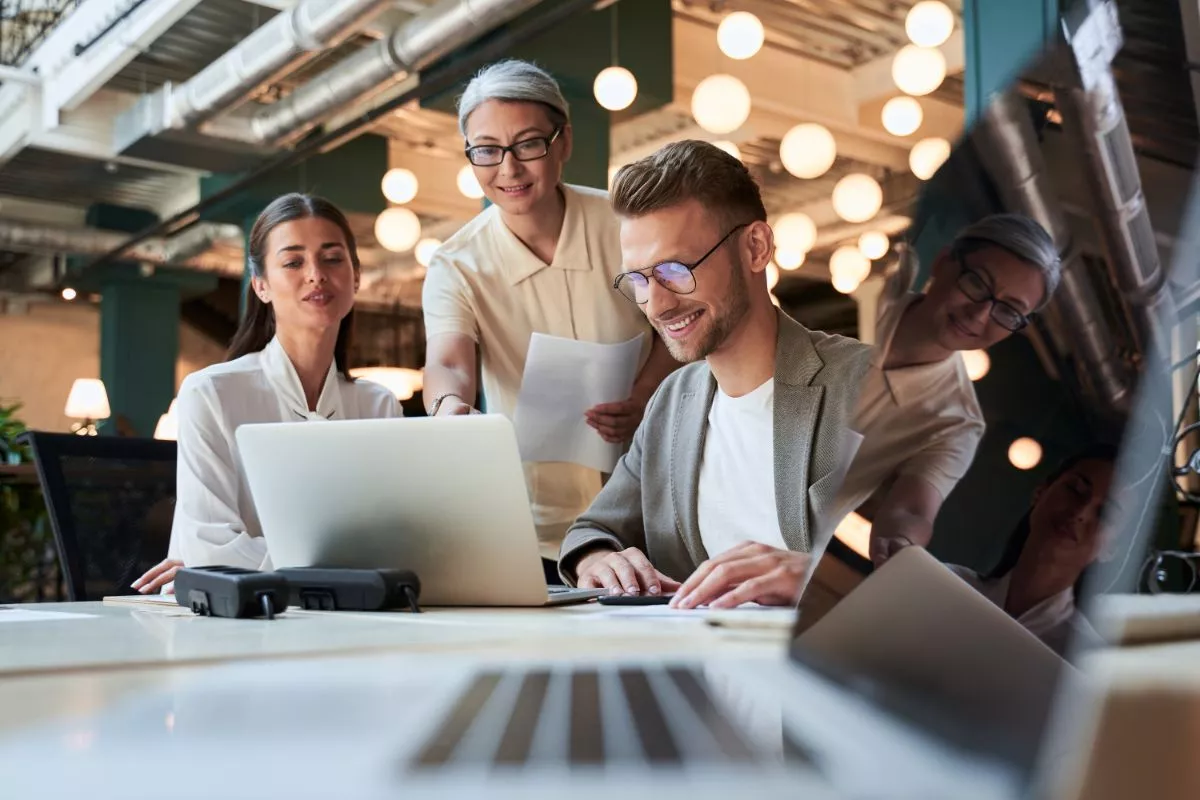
[559,312,871,584]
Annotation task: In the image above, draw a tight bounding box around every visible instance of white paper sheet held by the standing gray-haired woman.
[512,333,644,473]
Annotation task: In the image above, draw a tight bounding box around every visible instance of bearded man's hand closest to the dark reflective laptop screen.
[671,542,811,608]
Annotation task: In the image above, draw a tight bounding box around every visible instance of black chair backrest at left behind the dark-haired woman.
[24,432,176,601]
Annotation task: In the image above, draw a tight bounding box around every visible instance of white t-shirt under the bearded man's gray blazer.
[696,378,787,558]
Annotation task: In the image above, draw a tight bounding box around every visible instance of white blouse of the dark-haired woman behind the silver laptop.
[169,338,403,570]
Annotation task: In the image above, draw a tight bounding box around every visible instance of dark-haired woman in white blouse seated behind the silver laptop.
[133,194,402,594]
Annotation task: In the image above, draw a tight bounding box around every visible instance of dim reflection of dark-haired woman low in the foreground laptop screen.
[950,445,1116,655]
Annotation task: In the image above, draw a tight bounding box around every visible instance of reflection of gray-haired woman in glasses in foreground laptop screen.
[833,213,1061,566]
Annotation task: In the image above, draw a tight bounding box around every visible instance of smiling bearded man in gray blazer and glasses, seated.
[559,142,870,607]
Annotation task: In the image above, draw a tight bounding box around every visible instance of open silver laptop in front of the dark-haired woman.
[238,415,602,606]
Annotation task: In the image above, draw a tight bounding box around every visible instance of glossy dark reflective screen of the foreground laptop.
[792,9,1200,782]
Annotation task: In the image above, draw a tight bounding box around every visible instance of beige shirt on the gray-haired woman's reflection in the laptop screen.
[833,275,985,521]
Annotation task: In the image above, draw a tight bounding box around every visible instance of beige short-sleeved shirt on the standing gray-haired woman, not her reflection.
[422,185,653,559]
